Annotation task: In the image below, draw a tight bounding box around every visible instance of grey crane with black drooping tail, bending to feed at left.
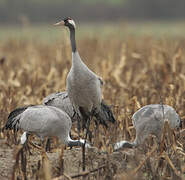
[5,105,89,146]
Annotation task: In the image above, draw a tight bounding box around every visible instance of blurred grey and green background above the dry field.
[0,0,185,39]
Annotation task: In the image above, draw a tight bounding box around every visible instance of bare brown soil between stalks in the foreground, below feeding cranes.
[0,137,134,179]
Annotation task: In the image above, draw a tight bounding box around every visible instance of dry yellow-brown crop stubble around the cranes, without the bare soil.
[0,35,185,179]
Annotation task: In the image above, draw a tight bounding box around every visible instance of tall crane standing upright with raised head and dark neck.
[55,17,103,134]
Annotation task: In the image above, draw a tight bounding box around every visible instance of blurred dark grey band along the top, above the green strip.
[0,0,185,24]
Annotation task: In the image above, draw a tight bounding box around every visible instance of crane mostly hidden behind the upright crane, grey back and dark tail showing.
[42,91,115,127]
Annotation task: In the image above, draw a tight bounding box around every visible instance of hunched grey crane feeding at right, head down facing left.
[114,104,182,150]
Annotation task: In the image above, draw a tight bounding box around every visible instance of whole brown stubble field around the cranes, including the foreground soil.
[0,27,185,180]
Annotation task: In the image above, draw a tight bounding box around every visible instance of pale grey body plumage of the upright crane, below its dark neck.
[67,52,102,115]
